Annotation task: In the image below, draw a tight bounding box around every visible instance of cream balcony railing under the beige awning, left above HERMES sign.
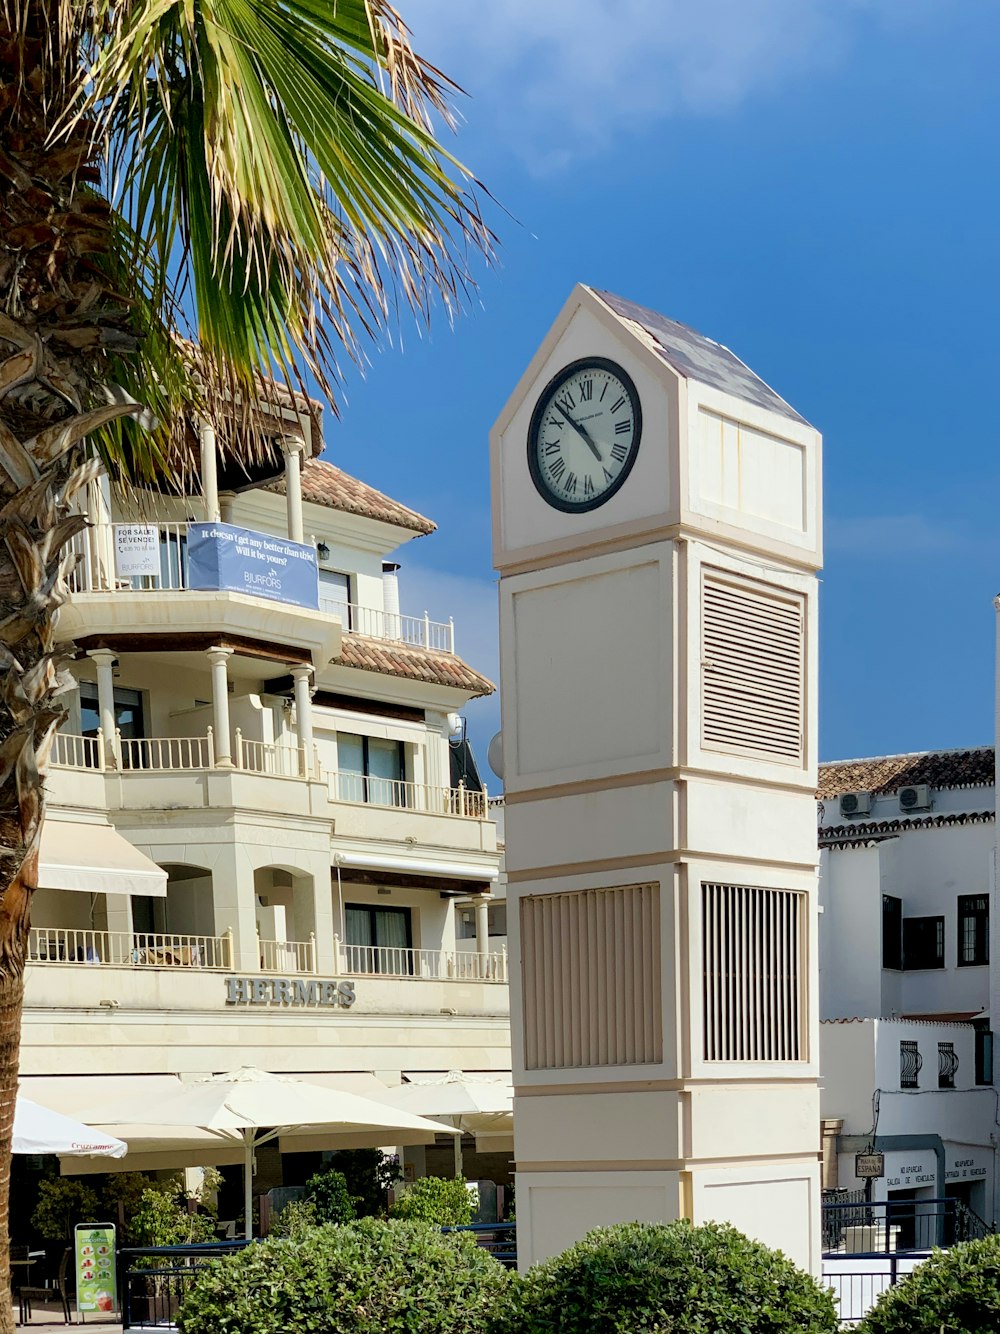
[28,926,233,970]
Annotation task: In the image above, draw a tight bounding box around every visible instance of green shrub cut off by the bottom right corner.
[859,1237,1000,1334]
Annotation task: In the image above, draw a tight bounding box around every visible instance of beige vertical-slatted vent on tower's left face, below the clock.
[521,884,663,1070]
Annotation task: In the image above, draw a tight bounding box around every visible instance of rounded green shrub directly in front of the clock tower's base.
[496,1221,837,1334]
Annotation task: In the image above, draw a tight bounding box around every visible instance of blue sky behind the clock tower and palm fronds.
[318,0,1000,786]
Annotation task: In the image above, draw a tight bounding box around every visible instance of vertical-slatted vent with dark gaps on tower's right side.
[701,884,807,1061]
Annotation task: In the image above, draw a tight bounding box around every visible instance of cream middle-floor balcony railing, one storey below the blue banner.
[49,727,489,820]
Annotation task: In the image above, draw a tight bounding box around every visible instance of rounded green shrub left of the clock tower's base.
[177,1219,509,1334]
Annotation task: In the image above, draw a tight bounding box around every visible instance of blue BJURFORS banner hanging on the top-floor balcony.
[188,523,320,611]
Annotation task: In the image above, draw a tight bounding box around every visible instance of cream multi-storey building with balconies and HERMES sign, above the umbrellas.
[14,418,511,1211]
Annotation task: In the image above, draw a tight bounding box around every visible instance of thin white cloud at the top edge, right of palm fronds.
[404,0,948,169]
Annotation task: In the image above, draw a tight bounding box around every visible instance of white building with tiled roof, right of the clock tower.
[819,746,1000,1222]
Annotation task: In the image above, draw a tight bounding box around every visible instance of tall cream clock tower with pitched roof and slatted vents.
[491,287,821,1270]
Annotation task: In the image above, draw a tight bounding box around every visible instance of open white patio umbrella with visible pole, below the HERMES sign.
[80,1066,455,1238]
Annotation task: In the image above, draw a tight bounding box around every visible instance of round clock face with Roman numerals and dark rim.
[528,356,643,514]
